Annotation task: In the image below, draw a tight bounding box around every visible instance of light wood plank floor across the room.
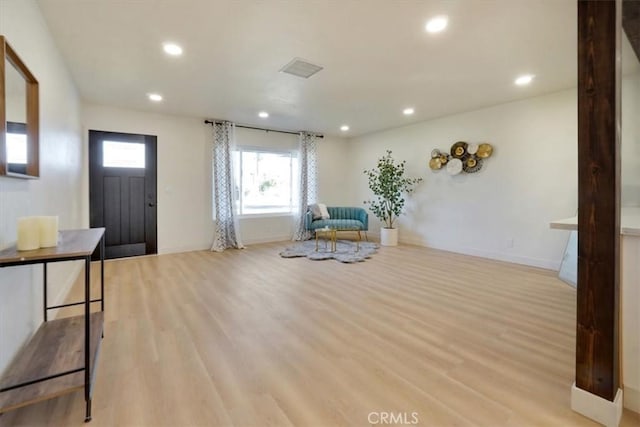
[0,243,640,427]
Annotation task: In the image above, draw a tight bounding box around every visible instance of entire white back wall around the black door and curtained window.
[83,104,347,249]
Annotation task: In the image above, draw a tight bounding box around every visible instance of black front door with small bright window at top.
[89,130,158,258]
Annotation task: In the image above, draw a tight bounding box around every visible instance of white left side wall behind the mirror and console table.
[0,0,88,372]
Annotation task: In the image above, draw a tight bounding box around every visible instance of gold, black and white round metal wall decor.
[429,141,493,175]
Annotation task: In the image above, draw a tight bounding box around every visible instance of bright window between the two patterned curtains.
[233,147,298,215]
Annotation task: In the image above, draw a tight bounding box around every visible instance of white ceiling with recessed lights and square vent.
[39,0,632,136]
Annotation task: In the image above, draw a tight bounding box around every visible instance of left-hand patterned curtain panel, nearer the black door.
[211,122,244,252]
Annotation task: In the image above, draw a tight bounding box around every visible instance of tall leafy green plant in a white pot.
[364,150,422,246]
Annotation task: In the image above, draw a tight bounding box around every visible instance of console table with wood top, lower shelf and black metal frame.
[0,228,104,422]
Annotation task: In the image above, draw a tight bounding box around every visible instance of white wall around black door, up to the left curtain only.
[82,104,213,253]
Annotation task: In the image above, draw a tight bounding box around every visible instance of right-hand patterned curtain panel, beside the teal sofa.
[293,132,318,240]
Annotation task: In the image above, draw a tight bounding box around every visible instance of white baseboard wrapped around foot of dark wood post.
[571,383,623,427]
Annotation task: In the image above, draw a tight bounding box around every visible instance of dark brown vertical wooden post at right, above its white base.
[576,0,621,401]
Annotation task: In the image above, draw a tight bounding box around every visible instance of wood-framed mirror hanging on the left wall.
[0,36,40,178]
